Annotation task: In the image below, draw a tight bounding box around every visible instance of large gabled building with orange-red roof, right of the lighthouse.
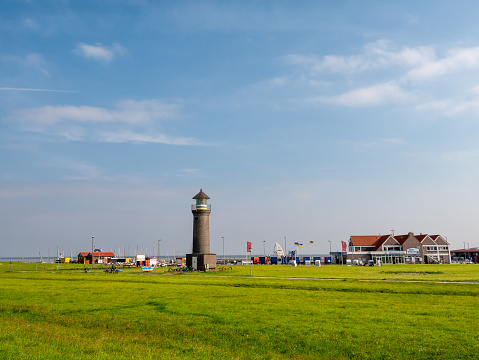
[346,232,451,264]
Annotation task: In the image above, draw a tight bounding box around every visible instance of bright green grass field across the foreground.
[0,263,479,359]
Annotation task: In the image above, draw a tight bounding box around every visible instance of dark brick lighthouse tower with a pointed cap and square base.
[186,189,216,270]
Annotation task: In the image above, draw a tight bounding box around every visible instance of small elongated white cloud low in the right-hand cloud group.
[316,83,413,107]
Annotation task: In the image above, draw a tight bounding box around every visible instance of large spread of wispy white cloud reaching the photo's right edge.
[280,40,479,116]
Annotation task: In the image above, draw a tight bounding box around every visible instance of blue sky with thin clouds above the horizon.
[0,0,479,257]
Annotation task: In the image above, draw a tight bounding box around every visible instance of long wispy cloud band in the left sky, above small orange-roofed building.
[9,99,210,145]
